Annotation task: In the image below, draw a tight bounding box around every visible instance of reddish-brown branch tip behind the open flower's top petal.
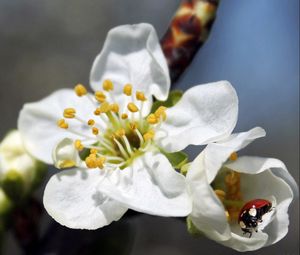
[161,0,218,83]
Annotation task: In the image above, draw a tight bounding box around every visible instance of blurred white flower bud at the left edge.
[0,130,44,197]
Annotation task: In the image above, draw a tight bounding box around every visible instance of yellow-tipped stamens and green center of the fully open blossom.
[57,80,166,169]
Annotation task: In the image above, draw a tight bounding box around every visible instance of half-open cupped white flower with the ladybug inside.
[187,127,298,251]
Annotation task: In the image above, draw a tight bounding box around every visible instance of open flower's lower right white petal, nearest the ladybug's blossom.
[99,152,191,216]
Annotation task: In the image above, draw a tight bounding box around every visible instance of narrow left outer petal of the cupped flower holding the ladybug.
[186,154,230,240]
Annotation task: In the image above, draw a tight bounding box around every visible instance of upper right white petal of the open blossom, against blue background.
[157,81,238,152]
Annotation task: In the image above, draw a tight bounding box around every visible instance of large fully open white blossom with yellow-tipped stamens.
[18,24,237,229]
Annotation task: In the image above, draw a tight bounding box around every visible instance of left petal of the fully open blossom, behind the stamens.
[18,89,95,164]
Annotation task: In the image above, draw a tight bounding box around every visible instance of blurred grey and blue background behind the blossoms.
[0,0,299,255]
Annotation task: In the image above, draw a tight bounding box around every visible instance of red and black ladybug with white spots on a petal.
[238,199,273,238]
